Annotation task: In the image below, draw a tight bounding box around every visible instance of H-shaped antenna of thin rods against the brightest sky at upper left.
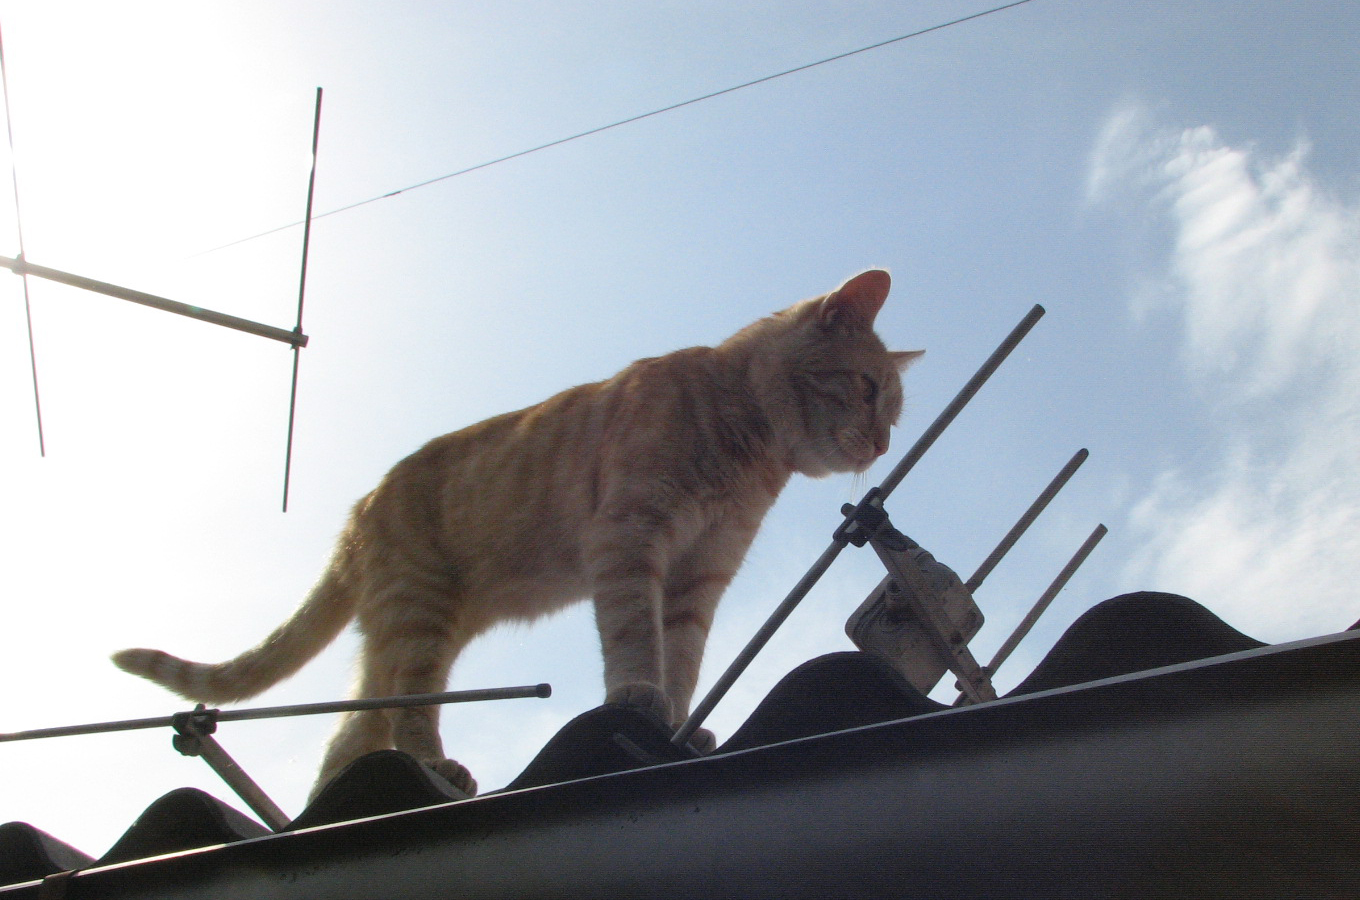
[0,24,322,513]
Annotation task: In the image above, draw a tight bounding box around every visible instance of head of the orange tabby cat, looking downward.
[732,269,925,477]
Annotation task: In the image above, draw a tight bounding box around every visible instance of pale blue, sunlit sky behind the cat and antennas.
[0,0,1360,856]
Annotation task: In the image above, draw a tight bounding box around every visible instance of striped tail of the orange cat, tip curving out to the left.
[113,567,355,703]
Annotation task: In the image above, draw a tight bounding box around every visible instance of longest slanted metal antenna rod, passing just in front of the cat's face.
[670,303,1043,746]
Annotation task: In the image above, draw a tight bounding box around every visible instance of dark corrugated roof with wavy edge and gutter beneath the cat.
[0,594,1360,897]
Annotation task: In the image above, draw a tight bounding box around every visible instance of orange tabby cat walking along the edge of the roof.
[113,269,925,795]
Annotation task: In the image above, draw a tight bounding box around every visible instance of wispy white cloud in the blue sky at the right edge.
[1088,106,1360,640]
